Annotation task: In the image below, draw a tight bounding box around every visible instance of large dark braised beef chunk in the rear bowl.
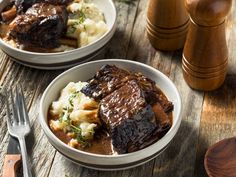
[9,3,68,48]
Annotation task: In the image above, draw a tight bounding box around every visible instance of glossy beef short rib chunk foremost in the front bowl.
[99,80,158,153]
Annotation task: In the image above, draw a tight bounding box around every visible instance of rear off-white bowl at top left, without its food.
[0,0,117,67]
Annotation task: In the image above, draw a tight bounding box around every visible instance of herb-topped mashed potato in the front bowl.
[49,82,100,147]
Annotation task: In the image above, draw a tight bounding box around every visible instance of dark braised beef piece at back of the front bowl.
[81,65,173,108]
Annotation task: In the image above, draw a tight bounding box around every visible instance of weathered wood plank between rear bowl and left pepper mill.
[127,0,175,75]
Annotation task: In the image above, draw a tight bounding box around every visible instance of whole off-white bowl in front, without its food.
[39,59,181,170]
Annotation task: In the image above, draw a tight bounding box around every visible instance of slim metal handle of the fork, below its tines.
[19,137,32,177]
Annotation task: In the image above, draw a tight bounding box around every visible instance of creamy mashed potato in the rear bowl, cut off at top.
[66,0,108,47]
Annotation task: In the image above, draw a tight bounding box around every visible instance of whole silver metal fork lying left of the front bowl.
[7,86,32,177]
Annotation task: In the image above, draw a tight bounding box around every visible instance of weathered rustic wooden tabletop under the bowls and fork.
[0,0,236,177]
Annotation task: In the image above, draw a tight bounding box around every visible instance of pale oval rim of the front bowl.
[39,59,182,159]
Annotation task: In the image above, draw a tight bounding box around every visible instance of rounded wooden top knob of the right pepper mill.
[185,0,232,26]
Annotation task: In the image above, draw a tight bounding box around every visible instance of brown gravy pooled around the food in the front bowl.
[48,89,173,155]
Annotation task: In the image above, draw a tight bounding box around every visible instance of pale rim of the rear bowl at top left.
[0,0,117,56]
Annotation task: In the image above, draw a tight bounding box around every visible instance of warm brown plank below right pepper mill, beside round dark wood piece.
[195,75,236,177]
